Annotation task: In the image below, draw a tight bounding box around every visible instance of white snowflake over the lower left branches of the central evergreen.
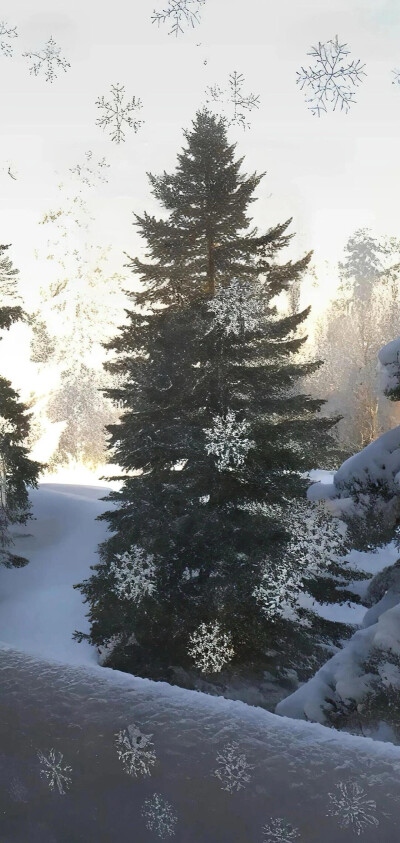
[110,544,156,603]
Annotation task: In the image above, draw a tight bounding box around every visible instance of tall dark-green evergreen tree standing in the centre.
[76,111,346,681]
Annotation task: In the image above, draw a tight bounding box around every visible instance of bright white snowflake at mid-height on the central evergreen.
[204,410,256,471]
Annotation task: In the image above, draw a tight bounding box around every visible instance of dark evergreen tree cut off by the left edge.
[0,246,41,567]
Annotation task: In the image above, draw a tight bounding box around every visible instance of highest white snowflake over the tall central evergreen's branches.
[208,278,263,337]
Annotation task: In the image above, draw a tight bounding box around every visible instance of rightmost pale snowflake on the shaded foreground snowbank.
[328,782,379,836]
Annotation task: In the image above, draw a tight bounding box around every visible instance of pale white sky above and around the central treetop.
[0,0,400,342]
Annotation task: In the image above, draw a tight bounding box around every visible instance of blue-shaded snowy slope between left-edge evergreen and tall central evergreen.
[0,483,108,664]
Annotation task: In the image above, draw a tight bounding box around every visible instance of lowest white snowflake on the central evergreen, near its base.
[188,623,234,673]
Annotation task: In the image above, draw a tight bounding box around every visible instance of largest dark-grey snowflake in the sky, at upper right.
[296,35,366,117]
